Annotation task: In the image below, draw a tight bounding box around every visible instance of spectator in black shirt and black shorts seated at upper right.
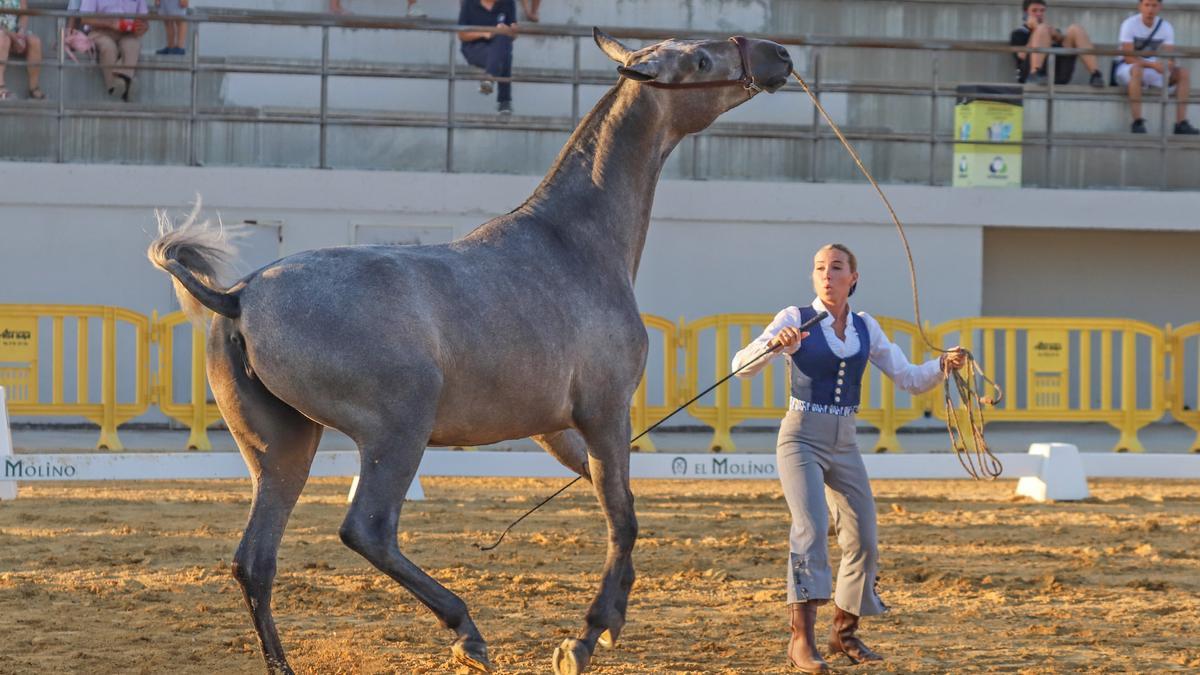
[1008,0,1104,86]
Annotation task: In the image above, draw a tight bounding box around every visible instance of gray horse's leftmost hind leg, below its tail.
[209,319,323,674]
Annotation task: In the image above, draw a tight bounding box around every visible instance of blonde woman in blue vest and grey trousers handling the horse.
[733,244,966,673]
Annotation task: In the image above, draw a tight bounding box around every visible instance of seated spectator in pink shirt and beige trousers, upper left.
[79,0,150,101]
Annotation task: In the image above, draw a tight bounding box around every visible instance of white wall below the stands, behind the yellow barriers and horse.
[0,163,1200,322]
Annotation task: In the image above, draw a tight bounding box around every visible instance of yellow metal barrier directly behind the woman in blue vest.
[680,313,924,452]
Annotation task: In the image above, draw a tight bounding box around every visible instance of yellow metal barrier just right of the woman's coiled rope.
[931,317,1165,453]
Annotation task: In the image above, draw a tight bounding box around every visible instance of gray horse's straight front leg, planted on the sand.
[553,405,637,675]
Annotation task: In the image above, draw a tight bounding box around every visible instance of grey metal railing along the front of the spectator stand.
[7,8,1200,189]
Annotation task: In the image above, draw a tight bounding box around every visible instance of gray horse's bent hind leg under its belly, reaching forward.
[341,410,491,671]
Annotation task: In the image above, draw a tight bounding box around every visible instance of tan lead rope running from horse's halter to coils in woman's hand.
[792,70,1004,480]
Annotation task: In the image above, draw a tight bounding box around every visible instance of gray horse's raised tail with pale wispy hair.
[146,197,241,325]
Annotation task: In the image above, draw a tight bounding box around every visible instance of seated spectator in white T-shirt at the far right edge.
[1115,0,1200,136]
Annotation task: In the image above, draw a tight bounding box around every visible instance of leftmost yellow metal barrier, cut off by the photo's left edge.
[0,305,150,450]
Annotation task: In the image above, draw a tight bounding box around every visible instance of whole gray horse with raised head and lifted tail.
[149,30,792,674]
